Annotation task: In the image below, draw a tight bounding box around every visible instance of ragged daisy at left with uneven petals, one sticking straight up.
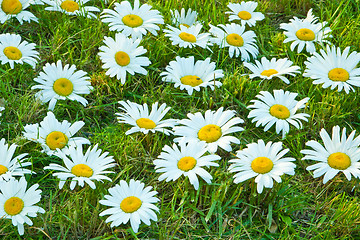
[23,112,90,155]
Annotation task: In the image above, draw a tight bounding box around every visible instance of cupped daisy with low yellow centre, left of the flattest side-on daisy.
[160,56,224,95]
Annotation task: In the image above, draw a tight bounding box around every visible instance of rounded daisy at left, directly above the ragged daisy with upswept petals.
[31,60,93,110]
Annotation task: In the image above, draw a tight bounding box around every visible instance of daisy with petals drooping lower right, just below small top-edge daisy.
[210,23,259,61]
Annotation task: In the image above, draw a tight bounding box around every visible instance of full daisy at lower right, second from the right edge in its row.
[229,140,296,193]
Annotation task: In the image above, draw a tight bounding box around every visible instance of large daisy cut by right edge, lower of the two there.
[301,126,360,184]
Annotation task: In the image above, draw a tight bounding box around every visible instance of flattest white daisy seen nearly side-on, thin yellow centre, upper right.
[244,57,300,84]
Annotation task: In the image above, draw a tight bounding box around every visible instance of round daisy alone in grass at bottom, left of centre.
[99,179,159,233]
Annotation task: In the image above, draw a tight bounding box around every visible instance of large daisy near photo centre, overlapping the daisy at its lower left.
[174,107,244,153]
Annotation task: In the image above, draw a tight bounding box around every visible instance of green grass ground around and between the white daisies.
[0,0,360,239]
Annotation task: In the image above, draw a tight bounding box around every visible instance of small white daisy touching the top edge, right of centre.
[225,1,265,27]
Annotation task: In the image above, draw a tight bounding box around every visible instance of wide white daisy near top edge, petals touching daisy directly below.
[101,0,164,39]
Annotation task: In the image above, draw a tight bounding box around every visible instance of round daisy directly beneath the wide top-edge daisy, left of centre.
[99,33,151,84]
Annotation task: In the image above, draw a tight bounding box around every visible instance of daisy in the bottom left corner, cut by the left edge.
[0,177,45,235]
